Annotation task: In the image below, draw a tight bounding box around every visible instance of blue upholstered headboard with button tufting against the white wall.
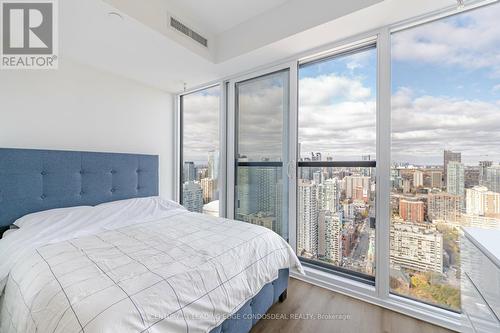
[0,148,159,228]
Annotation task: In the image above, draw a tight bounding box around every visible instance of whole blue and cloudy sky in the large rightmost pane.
[392,4,500,165]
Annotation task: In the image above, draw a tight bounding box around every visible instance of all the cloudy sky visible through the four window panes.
[184,4,500,165]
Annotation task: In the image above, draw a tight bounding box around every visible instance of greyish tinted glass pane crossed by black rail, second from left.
[235,70,289,239]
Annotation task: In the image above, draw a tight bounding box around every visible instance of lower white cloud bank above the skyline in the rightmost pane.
[391,88,500,164]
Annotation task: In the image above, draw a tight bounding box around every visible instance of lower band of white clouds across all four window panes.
[184,75,500,164]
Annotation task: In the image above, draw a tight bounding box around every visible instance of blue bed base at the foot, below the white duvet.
[210,269,289,333]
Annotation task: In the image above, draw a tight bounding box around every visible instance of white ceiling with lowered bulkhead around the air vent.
[59,0,455,92]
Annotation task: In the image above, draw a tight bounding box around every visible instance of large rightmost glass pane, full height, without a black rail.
[390,5,500,311]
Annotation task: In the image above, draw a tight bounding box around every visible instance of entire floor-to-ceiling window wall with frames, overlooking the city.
[181,4,500,319]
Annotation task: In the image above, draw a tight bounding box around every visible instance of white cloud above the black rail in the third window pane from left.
[299,74,376,160]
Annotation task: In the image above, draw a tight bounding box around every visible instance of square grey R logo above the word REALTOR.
[2,1,54,55]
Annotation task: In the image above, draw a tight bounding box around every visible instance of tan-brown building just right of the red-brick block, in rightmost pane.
[427,192,462,223]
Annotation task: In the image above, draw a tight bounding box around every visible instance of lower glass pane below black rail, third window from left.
[297,167,375,276]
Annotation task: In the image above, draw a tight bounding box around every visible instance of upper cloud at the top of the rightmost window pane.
[392,5,500,77]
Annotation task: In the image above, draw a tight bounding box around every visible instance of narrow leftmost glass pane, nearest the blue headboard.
[181,86,220,216]
